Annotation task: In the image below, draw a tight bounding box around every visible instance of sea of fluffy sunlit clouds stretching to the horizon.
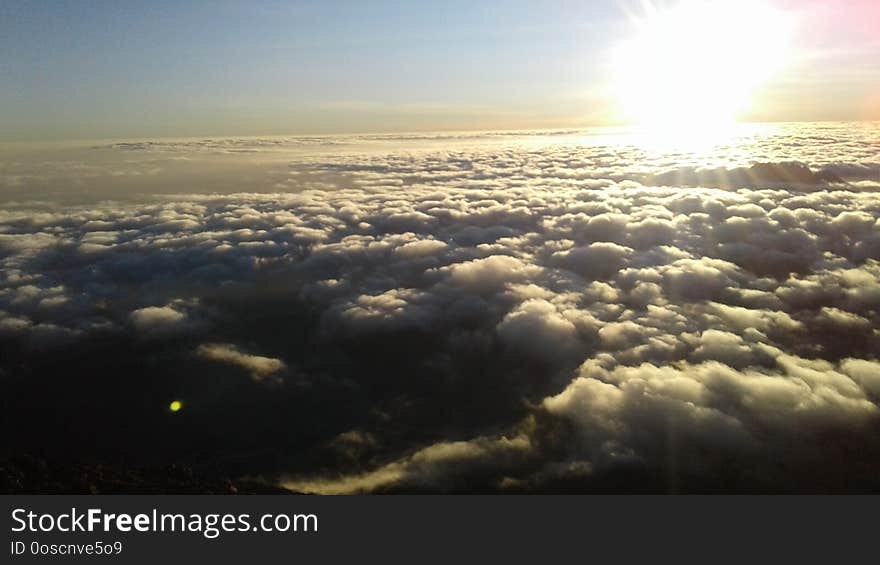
[0,125,880,493]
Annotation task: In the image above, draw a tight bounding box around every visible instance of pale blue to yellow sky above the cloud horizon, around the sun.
[0,0,880,141]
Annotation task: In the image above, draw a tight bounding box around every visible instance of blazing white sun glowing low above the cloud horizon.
[613,0,793,131]
